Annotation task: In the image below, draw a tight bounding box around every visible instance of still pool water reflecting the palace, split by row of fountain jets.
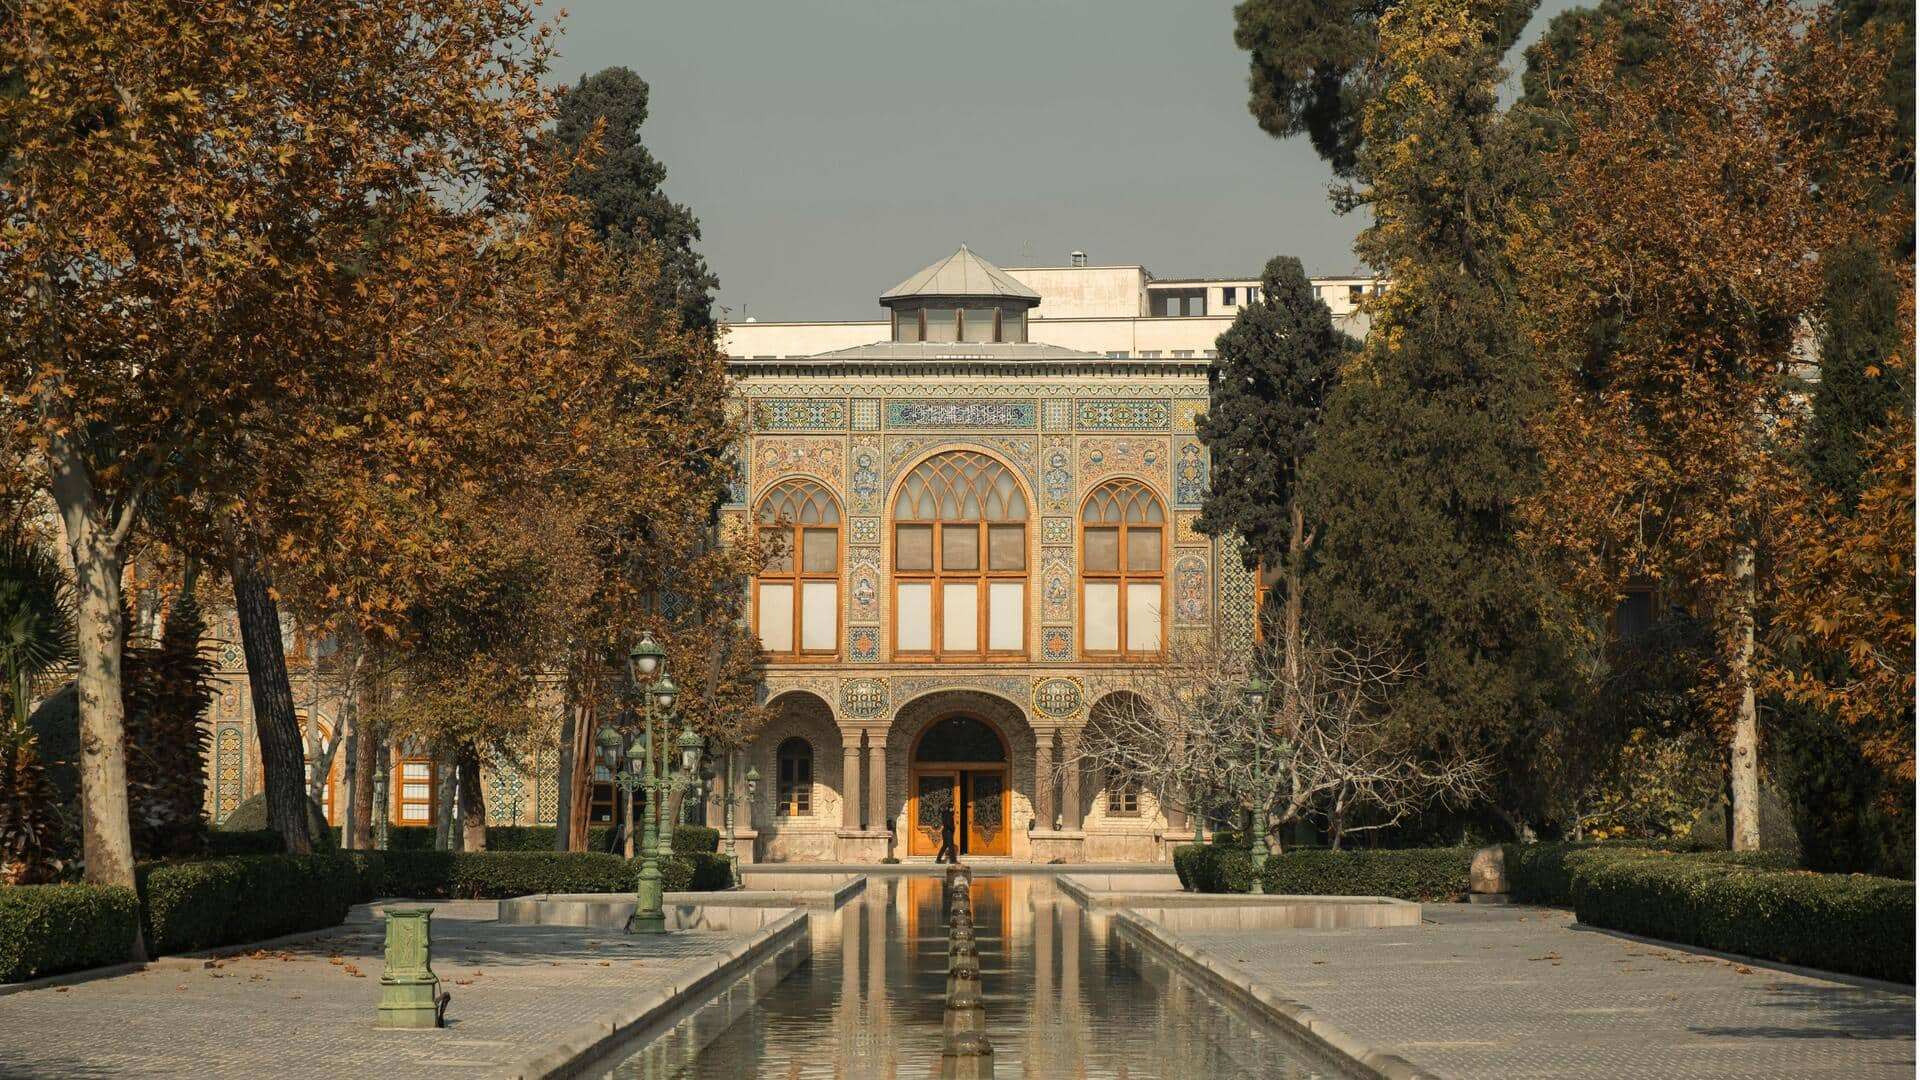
[591,874,1338,1080]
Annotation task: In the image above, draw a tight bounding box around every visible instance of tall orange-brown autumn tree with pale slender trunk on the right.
[1517,0,1910,847]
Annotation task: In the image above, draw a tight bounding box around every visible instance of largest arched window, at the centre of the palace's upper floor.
[893,450,1027,659]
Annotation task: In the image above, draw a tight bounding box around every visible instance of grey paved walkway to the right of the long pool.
[1177,903,1914,1080]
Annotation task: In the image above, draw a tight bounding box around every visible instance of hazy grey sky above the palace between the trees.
[547,0,1574,321]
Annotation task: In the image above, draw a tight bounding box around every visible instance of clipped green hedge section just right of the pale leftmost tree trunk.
[134,853,363,955]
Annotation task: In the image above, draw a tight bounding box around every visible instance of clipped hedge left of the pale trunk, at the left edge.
[0,884,140,982]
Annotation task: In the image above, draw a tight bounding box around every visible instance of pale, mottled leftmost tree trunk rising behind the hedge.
[48,449,146,895]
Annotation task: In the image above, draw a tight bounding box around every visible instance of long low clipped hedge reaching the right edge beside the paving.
[1567,851,1914,982]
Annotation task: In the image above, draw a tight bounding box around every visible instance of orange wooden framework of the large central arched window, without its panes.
[887,450,1033,661]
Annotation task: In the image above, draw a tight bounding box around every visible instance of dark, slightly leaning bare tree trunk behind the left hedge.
[232,544,313,855]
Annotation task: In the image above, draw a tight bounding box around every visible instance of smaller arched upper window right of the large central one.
[1081,479,1167,657]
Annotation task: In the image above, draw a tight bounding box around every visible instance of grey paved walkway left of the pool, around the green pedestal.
[0,901,764,1080]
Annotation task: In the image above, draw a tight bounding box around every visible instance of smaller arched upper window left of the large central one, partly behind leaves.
[753,480,839,659]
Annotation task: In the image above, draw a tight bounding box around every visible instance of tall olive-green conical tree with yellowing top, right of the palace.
[1302,4,1565,826]
